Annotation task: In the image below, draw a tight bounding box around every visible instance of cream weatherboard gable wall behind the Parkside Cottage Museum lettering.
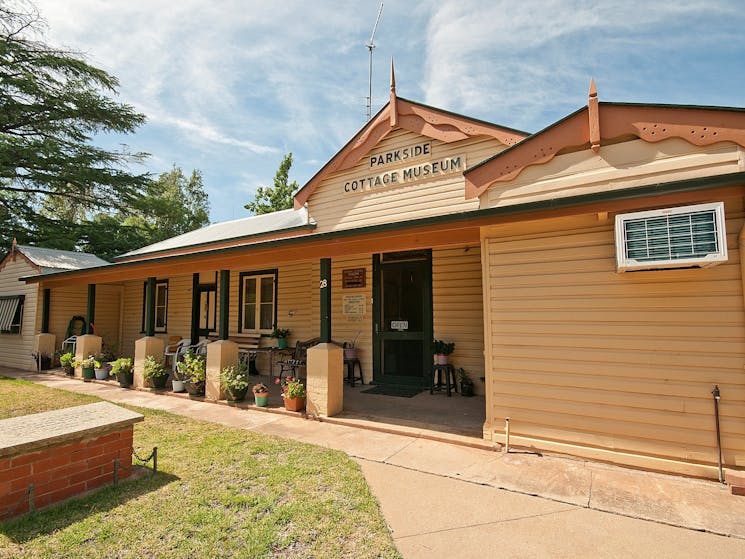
[308,129,505,233]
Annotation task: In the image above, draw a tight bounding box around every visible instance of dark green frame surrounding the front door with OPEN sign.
[372,252,434,386]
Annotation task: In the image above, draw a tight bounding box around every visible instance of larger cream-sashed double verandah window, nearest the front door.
[238,270,277,334]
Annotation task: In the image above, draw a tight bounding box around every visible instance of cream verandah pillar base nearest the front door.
[305,343,344,417]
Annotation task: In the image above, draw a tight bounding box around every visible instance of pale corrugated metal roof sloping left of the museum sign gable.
[117,208,314,260]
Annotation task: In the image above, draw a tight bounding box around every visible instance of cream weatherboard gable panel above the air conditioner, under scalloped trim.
[481,138,745,208]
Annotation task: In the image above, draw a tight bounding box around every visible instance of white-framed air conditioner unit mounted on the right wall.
[616,202,727,272]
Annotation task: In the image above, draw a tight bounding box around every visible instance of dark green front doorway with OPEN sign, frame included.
[373,250,432,385]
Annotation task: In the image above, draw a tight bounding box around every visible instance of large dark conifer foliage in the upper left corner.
[0,2,149,249]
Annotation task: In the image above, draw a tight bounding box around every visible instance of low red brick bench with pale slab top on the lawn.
[0,402,144,520]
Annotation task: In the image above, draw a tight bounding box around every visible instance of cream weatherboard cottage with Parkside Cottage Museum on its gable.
[16,76,745,477]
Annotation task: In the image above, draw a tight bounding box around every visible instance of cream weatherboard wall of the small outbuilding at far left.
[0,256,39,370]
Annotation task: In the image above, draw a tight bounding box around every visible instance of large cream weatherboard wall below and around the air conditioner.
[482,200,745,476]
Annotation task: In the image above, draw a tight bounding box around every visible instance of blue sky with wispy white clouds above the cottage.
[34,0,745,222]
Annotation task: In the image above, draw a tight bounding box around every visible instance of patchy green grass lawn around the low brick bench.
[0,377,399,559]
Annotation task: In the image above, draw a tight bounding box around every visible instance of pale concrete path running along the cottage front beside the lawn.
[5,370,745,559]
